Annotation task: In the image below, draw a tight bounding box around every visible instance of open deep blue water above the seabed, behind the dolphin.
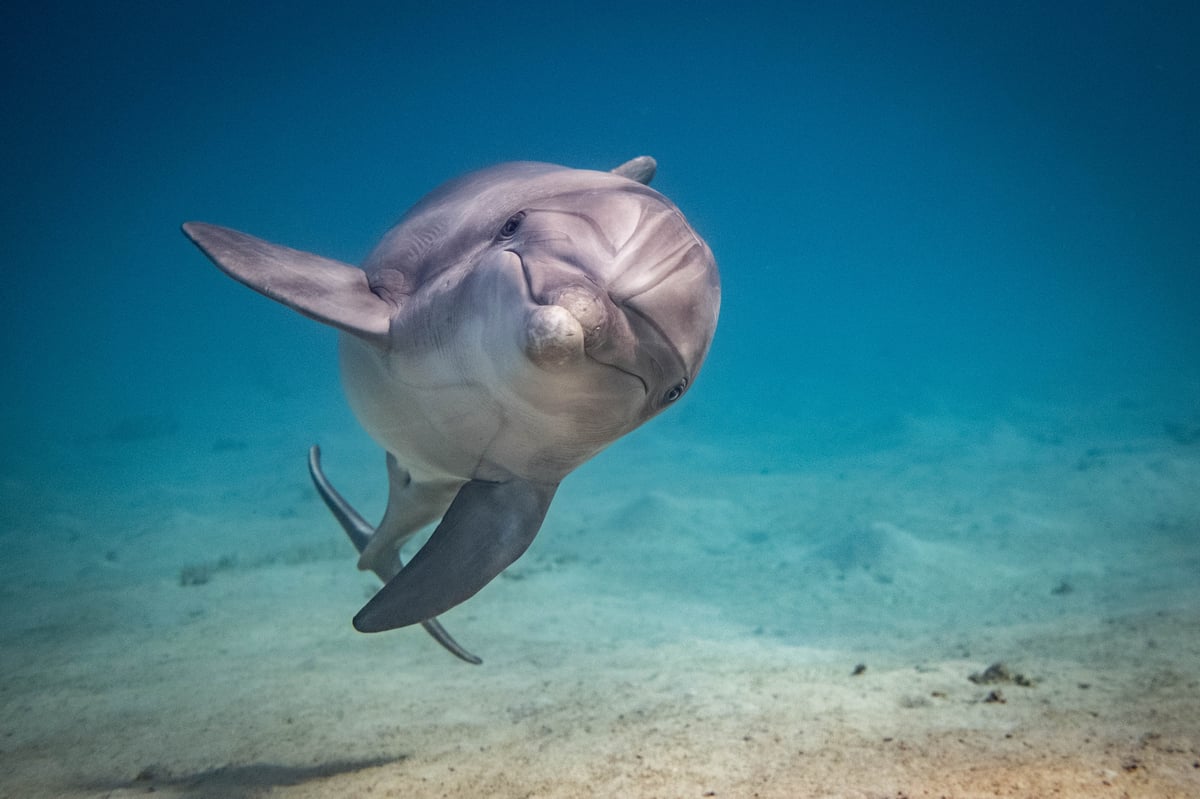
[0,2,1200,520]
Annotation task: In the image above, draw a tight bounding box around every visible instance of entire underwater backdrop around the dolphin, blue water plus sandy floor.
[0,2,1200,797]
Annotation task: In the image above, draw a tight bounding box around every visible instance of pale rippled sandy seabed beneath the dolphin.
[0,393,1200,799]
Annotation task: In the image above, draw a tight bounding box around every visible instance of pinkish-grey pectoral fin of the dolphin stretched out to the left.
[184,222,396,341]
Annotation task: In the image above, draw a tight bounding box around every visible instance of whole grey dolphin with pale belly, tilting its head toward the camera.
[184,156,721,663]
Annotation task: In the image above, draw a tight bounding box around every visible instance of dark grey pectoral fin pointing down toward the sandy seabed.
[354,479,558,632]
